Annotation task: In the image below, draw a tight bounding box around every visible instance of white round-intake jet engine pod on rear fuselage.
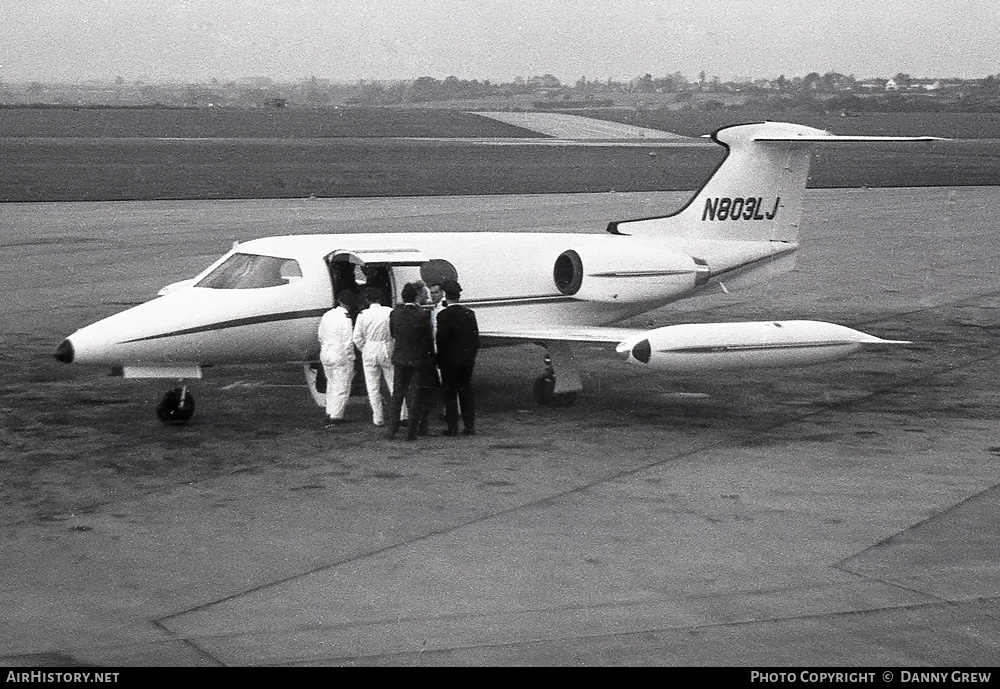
[552,243,709,304]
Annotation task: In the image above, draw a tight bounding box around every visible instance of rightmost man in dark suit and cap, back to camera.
[437,280,479,435]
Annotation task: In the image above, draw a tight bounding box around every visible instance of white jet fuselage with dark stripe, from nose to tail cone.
[56,232,794,367]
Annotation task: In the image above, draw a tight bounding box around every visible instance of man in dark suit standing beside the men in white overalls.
[387,282,437,440]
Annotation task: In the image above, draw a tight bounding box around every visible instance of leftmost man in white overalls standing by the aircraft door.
[318,290,355,426]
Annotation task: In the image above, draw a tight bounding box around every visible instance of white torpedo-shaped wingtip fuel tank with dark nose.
[617,321,909,373]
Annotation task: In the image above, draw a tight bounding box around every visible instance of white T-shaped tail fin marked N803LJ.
[608,122,936,242]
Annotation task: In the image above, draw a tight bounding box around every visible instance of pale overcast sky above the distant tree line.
[0,0,1000,83]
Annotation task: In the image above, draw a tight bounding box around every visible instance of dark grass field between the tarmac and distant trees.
[0,109,1000,202]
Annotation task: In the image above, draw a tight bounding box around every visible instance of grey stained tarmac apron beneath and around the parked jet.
[0,187,1000,667]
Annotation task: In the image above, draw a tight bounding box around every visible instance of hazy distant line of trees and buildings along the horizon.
[0,72,1000,111]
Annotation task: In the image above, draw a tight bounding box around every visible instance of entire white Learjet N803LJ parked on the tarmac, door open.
[55,122,934,423]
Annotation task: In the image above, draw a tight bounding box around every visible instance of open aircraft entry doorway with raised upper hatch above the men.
[326,249,427,306]
